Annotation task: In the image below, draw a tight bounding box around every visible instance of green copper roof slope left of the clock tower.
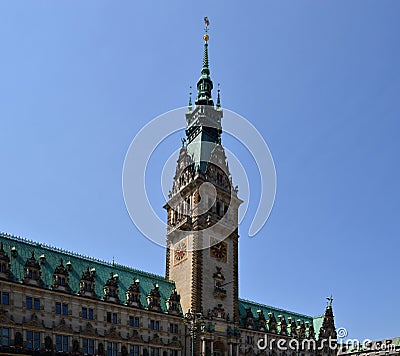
[0,233,179,312]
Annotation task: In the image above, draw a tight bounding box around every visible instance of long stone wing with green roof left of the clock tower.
[0,235,185,355]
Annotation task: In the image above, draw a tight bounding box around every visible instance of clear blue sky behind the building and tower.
[0,0,400,339]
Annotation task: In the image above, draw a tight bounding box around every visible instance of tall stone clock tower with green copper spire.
[165,29,242,323]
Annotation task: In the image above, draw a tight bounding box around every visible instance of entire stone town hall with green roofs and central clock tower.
[0,23,336,356]
